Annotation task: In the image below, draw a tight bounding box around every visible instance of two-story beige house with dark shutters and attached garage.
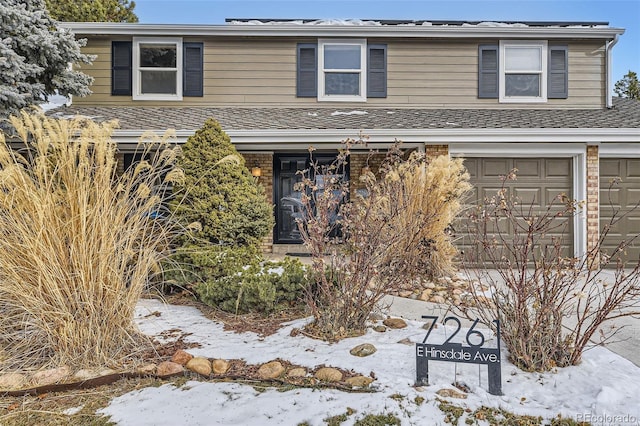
[57,20,640,258]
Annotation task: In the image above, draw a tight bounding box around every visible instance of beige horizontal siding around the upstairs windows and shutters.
[74,38,605,108]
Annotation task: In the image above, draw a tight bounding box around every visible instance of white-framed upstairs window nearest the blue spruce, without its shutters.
[133,37,182,100]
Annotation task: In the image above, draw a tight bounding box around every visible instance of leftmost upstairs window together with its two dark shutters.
[111,37,204,101]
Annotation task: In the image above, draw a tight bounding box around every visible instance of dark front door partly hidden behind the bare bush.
[273,153,348,244]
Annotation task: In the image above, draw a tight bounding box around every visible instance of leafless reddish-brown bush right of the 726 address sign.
[462,170,640,371]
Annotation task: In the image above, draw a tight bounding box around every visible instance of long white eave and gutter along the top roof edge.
[60,22,625,39]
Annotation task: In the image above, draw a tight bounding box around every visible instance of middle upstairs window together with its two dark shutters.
[296,39,387,102]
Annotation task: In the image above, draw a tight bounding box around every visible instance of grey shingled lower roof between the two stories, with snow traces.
[49,98,640,131]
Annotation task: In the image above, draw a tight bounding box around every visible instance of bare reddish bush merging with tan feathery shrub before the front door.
[299,140,470,339]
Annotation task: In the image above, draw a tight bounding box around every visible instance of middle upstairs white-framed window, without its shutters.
[318,40,367,101]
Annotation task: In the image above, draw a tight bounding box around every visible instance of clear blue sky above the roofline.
[135,0,640,82]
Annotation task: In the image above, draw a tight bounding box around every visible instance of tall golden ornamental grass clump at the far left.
[0,114,180,370]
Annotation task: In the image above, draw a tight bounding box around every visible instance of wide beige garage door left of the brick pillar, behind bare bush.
[458,158,573,263]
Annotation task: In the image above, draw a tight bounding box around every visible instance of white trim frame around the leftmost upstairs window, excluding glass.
[132,37,182,101]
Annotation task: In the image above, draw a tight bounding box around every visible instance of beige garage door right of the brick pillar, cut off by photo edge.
[600,158,640,263]
